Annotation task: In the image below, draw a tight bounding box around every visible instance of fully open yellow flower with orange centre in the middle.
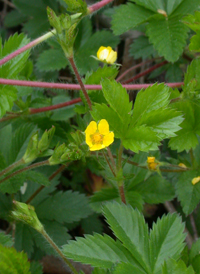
[85,119,114,151]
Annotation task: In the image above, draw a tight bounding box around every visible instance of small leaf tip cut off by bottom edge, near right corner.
[162,259,195,274]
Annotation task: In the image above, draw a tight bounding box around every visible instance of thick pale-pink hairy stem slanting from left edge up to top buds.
[0,29,56,66]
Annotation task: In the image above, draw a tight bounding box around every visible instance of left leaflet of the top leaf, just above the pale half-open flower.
[111,3,154,35]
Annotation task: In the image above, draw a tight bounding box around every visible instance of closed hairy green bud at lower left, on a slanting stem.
[11,201,44,232]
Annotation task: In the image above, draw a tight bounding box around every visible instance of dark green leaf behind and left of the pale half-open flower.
[74,30,119,74]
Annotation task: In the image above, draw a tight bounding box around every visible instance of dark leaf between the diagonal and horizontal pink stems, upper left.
[36,48,68,71]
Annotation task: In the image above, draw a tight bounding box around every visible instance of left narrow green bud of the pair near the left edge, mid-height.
[22,132,38,164]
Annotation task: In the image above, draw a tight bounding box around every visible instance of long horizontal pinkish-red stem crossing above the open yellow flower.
[0,78,184,90]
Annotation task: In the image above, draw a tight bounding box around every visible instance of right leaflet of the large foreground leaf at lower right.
[150,214,185,273]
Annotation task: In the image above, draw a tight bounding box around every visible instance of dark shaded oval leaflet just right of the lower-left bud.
[36,190,92,223]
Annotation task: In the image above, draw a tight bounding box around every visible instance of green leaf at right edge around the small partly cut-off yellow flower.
[176,171,200,215]
